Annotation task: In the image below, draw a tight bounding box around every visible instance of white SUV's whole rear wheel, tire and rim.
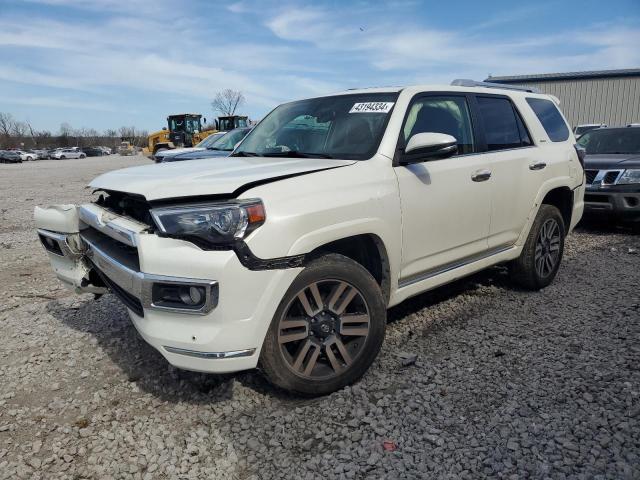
[509,204,566,290]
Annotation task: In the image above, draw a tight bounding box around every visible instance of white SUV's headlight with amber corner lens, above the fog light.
[151,200,266,248]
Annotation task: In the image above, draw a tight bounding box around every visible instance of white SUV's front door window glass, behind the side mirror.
[404,96,474,155]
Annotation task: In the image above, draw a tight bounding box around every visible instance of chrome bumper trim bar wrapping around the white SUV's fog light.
[82,237,218,315]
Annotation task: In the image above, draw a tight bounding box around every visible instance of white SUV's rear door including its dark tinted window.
[474,94,546,249]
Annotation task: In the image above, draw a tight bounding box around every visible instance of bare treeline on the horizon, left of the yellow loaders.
[0,112,148,150]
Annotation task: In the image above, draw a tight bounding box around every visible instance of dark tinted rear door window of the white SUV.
[477,97,531,151]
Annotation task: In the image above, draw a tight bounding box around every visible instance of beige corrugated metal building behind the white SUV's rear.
[486,68,640,127]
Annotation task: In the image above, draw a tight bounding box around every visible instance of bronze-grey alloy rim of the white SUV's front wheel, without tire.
[278,280,370,380]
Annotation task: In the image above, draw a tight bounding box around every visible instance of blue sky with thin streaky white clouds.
[0,0,640,132]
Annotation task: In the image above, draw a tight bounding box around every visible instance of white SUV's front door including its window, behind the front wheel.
[395,93,492,287]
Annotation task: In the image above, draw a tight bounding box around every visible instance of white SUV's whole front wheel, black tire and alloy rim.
[260,254,387,395]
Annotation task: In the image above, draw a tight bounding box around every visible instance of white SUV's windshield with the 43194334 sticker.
[233,93,398,160]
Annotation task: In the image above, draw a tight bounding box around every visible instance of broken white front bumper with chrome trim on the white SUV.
[35,204,300,373]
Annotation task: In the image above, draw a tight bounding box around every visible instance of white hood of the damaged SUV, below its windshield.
[89,157,355,201]
